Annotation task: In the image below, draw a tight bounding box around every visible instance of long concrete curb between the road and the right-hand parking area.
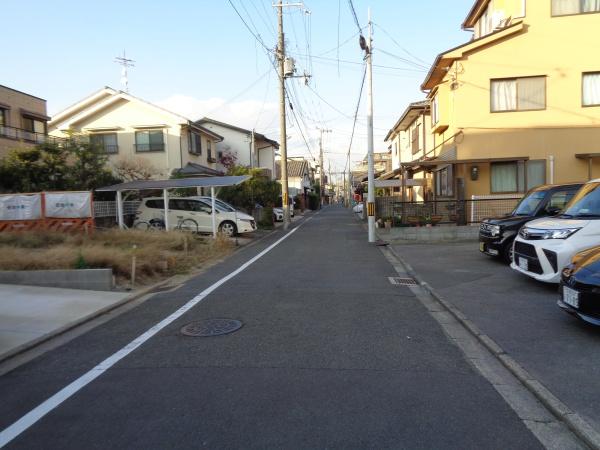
[388,246,600,450]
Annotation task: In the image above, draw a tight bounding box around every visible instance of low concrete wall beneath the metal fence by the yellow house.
[377,225,479,243]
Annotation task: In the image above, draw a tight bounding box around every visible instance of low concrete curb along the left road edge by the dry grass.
[0,224,288,364]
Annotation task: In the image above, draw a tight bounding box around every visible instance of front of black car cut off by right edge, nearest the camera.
[558,247,600,325]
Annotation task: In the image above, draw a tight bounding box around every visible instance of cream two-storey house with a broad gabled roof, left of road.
[48,87,223,178]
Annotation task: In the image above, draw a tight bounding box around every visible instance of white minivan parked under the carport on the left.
[133,197,256,236]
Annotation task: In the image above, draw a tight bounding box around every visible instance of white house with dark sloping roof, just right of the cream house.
[195,117,279,180]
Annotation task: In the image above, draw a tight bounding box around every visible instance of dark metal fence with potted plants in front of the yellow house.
[375,197,519,225]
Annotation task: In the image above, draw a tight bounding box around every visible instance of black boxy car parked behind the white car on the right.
[479,183,583,263]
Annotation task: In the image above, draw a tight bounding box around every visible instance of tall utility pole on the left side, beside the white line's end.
[277,3,290,230]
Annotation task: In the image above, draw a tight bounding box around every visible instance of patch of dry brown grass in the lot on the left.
[0,230,233,285]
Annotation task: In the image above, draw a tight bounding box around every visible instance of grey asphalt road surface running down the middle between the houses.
[0,207,540,449]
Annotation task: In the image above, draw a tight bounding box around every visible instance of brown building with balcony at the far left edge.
[0,85,50,158]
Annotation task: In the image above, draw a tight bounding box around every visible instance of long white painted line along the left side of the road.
[0,223,314,448]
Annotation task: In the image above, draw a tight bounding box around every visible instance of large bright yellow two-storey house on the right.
[402,0,600,199]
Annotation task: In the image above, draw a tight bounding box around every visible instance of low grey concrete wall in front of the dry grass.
[0,269,114,291]
